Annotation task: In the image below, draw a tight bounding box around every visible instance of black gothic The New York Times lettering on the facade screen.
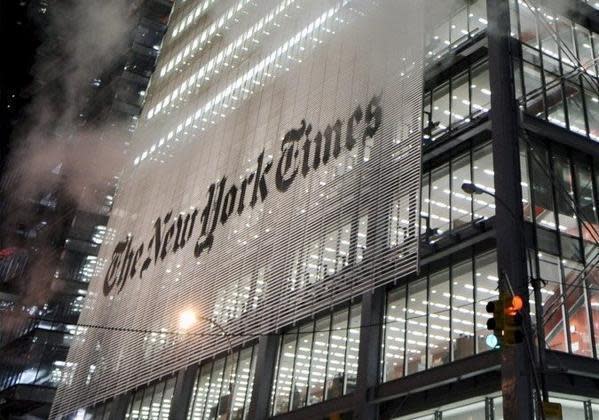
[103,95,383,296]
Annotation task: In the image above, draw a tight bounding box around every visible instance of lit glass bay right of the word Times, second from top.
[423,59,491,145]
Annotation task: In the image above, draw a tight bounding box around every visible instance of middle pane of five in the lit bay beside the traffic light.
[428,269,451,368]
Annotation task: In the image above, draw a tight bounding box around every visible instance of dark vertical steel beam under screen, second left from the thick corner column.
[247,335,279,420]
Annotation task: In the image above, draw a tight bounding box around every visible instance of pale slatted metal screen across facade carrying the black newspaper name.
[53,0,422,416]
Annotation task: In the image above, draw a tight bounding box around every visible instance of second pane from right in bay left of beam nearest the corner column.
[325,310,348,400]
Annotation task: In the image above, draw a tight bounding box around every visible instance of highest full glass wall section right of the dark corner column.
[511,0,599,141]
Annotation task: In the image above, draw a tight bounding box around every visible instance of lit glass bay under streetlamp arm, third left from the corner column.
[187,346,256,420]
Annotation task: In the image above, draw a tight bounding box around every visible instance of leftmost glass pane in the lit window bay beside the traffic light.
[383,287,406,382]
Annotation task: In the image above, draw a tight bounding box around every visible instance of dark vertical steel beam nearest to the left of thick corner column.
[354,287,385,420]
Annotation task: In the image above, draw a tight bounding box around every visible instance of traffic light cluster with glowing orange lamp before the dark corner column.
[486,294,524,348]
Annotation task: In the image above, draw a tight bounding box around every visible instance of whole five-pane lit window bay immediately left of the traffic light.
[381,251,498,381]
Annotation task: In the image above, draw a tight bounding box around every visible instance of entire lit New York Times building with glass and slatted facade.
[52,0,599,420]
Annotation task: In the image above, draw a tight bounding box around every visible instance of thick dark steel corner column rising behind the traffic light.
[487,0,534,419]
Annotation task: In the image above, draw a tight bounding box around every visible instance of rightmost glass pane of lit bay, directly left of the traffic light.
[474,252,499,352]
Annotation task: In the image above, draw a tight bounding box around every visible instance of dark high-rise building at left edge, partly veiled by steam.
[0,0,172,419]
